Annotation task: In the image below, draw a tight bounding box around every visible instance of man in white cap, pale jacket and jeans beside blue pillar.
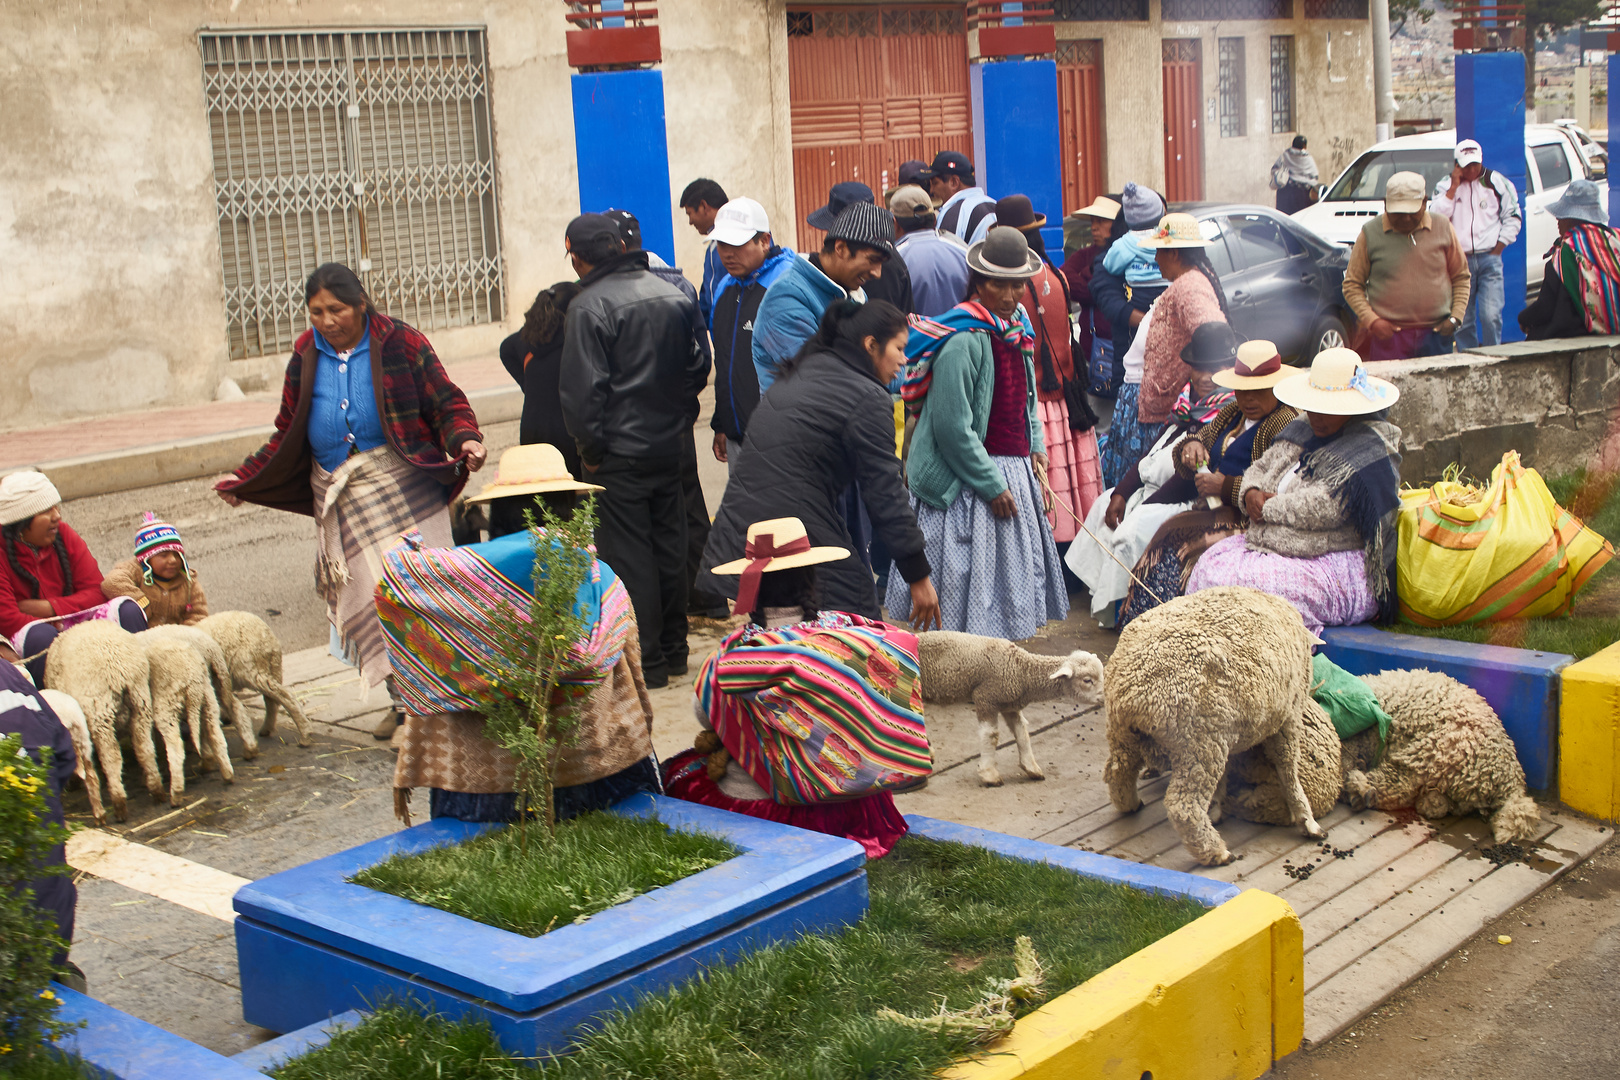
[1429,139,1521,348]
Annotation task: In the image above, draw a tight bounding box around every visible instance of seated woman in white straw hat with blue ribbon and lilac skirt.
[1187,348,1401,631]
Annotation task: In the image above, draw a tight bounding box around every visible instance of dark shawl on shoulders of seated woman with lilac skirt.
[1273,416,1401,623]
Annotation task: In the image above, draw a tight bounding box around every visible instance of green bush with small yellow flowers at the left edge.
[0,735,73,1075]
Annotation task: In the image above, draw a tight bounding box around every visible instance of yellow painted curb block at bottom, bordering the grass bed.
[944,889,1306,1080]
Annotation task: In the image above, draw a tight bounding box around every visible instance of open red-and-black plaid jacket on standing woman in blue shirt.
[215,313,483,517]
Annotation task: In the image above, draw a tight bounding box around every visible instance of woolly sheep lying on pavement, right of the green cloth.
[1343,669,1541,844]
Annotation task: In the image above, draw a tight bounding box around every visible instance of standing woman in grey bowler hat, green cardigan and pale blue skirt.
[888,225,1069,641]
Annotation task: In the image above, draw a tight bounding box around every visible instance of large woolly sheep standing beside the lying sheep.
[1103,588,1324,866]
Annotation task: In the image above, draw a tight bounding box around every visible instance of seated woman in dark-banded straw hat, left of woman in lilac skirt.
[1119,338,1298,630]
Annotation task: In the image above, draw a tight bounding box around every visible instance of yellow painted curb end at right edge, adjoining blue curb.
[1558,644,1620,821]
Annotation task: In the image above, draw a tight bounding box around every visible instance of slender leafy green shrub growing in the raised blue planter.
[483,499,609,850]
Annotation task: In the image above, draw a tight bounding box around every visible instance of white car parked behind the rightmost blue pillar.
[1293,123,1609,293]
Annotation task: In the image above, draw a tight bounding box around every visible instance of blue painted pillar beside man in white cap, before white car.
[1456,52,1522,342]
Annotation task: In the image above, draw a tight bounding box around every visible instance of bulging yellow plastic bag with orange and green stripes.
[1395,450,1615,627]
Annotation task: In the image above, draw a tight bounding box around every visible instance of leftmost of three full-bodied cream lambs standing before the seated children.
[45,619,157,821]
